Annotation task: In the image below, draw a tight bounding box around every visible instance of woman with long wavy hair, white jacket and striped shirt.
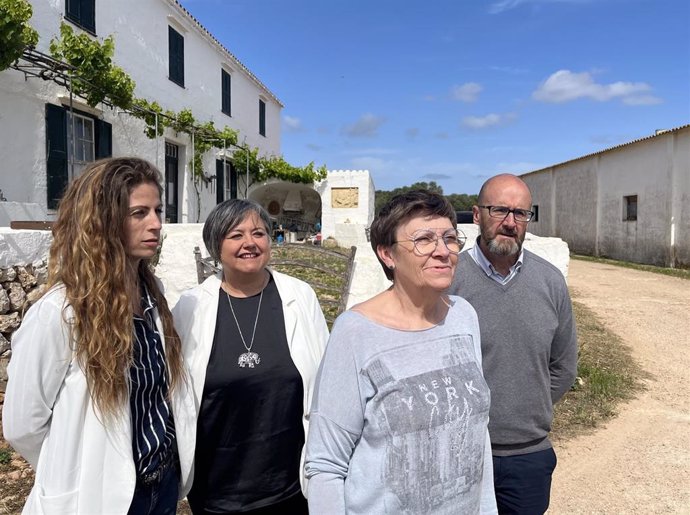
[3,158,195,514]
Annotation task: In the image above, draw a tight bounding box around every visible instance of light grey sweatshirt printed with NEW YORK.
[306,297,496,515]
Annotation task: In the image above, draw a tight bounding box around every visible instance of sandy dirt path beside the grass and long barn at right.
[549,260,690,515]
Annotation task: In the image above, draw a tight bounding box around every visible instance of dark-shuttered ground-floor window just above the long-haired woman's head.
[46,104,113,209]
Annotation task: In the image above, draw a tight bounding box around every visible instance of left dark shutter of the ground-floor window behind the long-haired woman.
[46,104,68,209]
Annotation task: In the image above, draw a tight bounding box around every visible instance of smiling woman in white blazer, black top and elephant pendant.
[173,199,328,515]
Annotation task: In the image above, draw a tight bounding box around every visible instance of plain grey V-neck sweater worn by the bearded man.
[451,250,577,456]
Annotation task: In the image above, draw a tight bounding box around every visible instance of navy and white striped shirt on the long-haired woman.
[129,287,175,476]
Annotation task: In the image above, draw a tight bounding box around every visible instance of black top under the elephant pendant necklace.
[188,277,304,513]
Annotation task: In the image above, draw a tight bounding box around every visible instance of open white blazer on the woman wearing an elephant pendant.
[172,270,328,495]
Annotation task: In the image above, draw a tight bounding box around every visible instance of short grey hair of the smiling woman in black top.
[201,198,272,262]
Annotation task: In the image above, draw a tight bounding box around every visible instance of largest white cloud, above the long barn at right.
[532,70,661,105]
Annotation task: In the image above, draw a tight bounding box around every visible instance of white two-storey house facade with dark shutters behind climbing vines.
[0,0,283,223]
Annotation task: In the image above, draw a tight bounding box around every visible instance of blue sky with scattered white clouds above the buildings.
[176,0,690,194]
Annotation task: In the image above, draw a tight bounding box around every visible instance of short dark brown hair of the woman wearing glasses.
[369,190,457,281]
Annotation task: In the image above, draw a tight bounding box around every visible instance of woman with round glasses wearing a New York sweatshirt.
[306,190,496,515]
